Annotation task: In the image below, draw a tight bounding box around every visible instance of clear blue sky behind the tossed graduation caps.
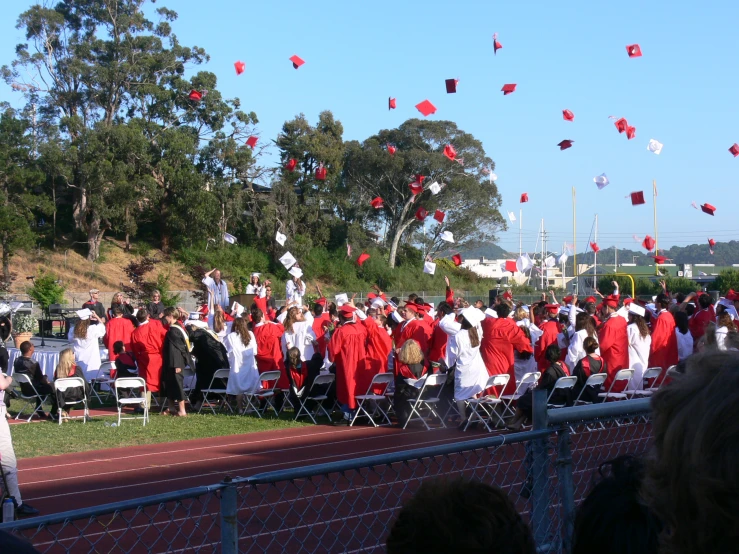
[0,0,739,251]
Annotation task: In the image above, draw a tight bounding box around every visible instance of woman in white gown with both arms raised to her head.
[439,307,488,428]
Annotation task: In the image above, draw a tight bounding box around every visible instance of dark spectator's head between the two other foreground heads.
[572,452,662,554]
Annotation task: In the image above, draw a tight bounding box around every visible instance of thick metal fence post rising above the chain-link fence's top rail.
[529,389,549,552]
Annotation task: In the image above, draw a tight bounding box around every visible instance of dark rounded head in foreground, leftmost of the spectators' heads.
[386,479,536,554]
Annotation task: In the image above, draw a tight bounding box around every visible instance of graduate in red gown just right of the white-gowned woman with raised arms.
[480,302,533,394]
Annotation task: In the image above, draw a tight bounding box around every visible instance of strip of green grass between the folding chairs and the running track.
[10,410,312,458]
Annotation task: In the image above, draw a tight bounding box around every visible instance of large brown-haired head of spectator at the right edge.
[644,352,739,554]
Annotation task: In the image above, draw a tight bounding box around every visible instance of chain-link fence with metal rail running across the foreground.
[0,391,651,554]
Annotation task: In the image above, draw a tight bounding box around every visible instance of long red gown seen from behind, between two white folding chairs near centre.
[328,316,372,410]
